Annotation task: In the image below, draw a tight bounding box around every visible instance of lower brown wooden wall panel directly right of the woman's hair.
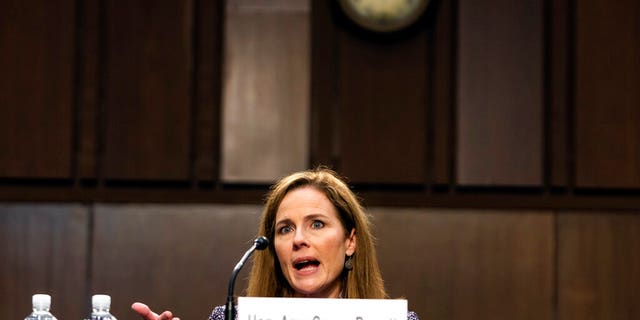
[370,208,554,320]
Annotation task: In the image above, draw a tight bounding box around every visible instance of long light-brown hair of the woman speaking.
[247,167,387,299]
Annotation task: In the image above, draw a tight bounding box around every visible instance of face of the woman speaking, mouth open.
[274,187,356,298]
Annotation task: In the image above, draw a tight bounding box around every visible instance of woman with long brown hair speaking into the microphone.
[132,168,418,320]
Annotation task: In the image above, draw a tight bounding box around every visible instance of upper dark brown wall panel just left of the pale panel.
[101,1,192,180]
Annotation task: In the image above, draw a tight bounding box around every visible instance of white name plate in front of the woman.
[238,297,407,320]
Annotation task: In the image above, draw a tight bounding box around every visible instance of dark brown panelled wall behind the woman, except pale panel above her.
[0,0,640,320]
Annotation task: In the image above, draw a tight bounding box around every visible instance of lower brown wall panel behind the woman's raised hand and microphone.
[91,205,261,320]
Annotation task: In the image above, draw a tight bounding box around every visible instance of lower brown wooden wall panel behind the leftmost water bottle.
[0,203,89,319]
